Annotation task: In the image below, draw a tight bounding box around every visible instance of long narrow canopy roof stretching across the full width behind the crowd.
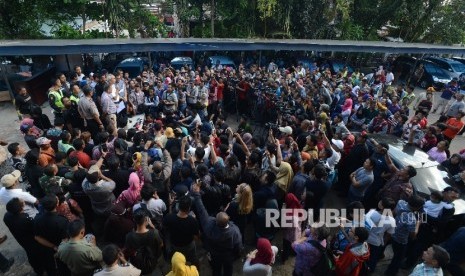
[0,38,465,56]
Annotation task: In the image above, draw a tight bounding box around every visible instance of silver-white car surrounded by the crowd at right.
[367,134,465,215]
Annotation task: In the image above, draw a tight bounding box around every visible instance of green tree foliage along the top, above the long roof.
[0,0,465,44]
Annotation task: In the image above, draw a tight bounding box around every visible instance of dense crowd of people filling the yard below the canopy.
[0,57,465,276]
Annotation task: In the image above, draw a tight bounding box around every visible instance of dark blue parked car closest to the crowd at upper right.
[417,60,452,90]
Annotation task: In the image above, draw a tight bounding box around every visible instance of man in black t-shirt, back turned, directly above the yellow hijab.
[163,196,200,267]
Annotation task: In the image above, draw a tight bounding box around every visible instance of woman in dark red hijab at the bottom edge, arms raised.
[242,238,278,276]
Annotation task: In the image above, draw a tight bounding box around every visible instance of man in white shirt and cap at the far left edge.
[0,170,39,218]
